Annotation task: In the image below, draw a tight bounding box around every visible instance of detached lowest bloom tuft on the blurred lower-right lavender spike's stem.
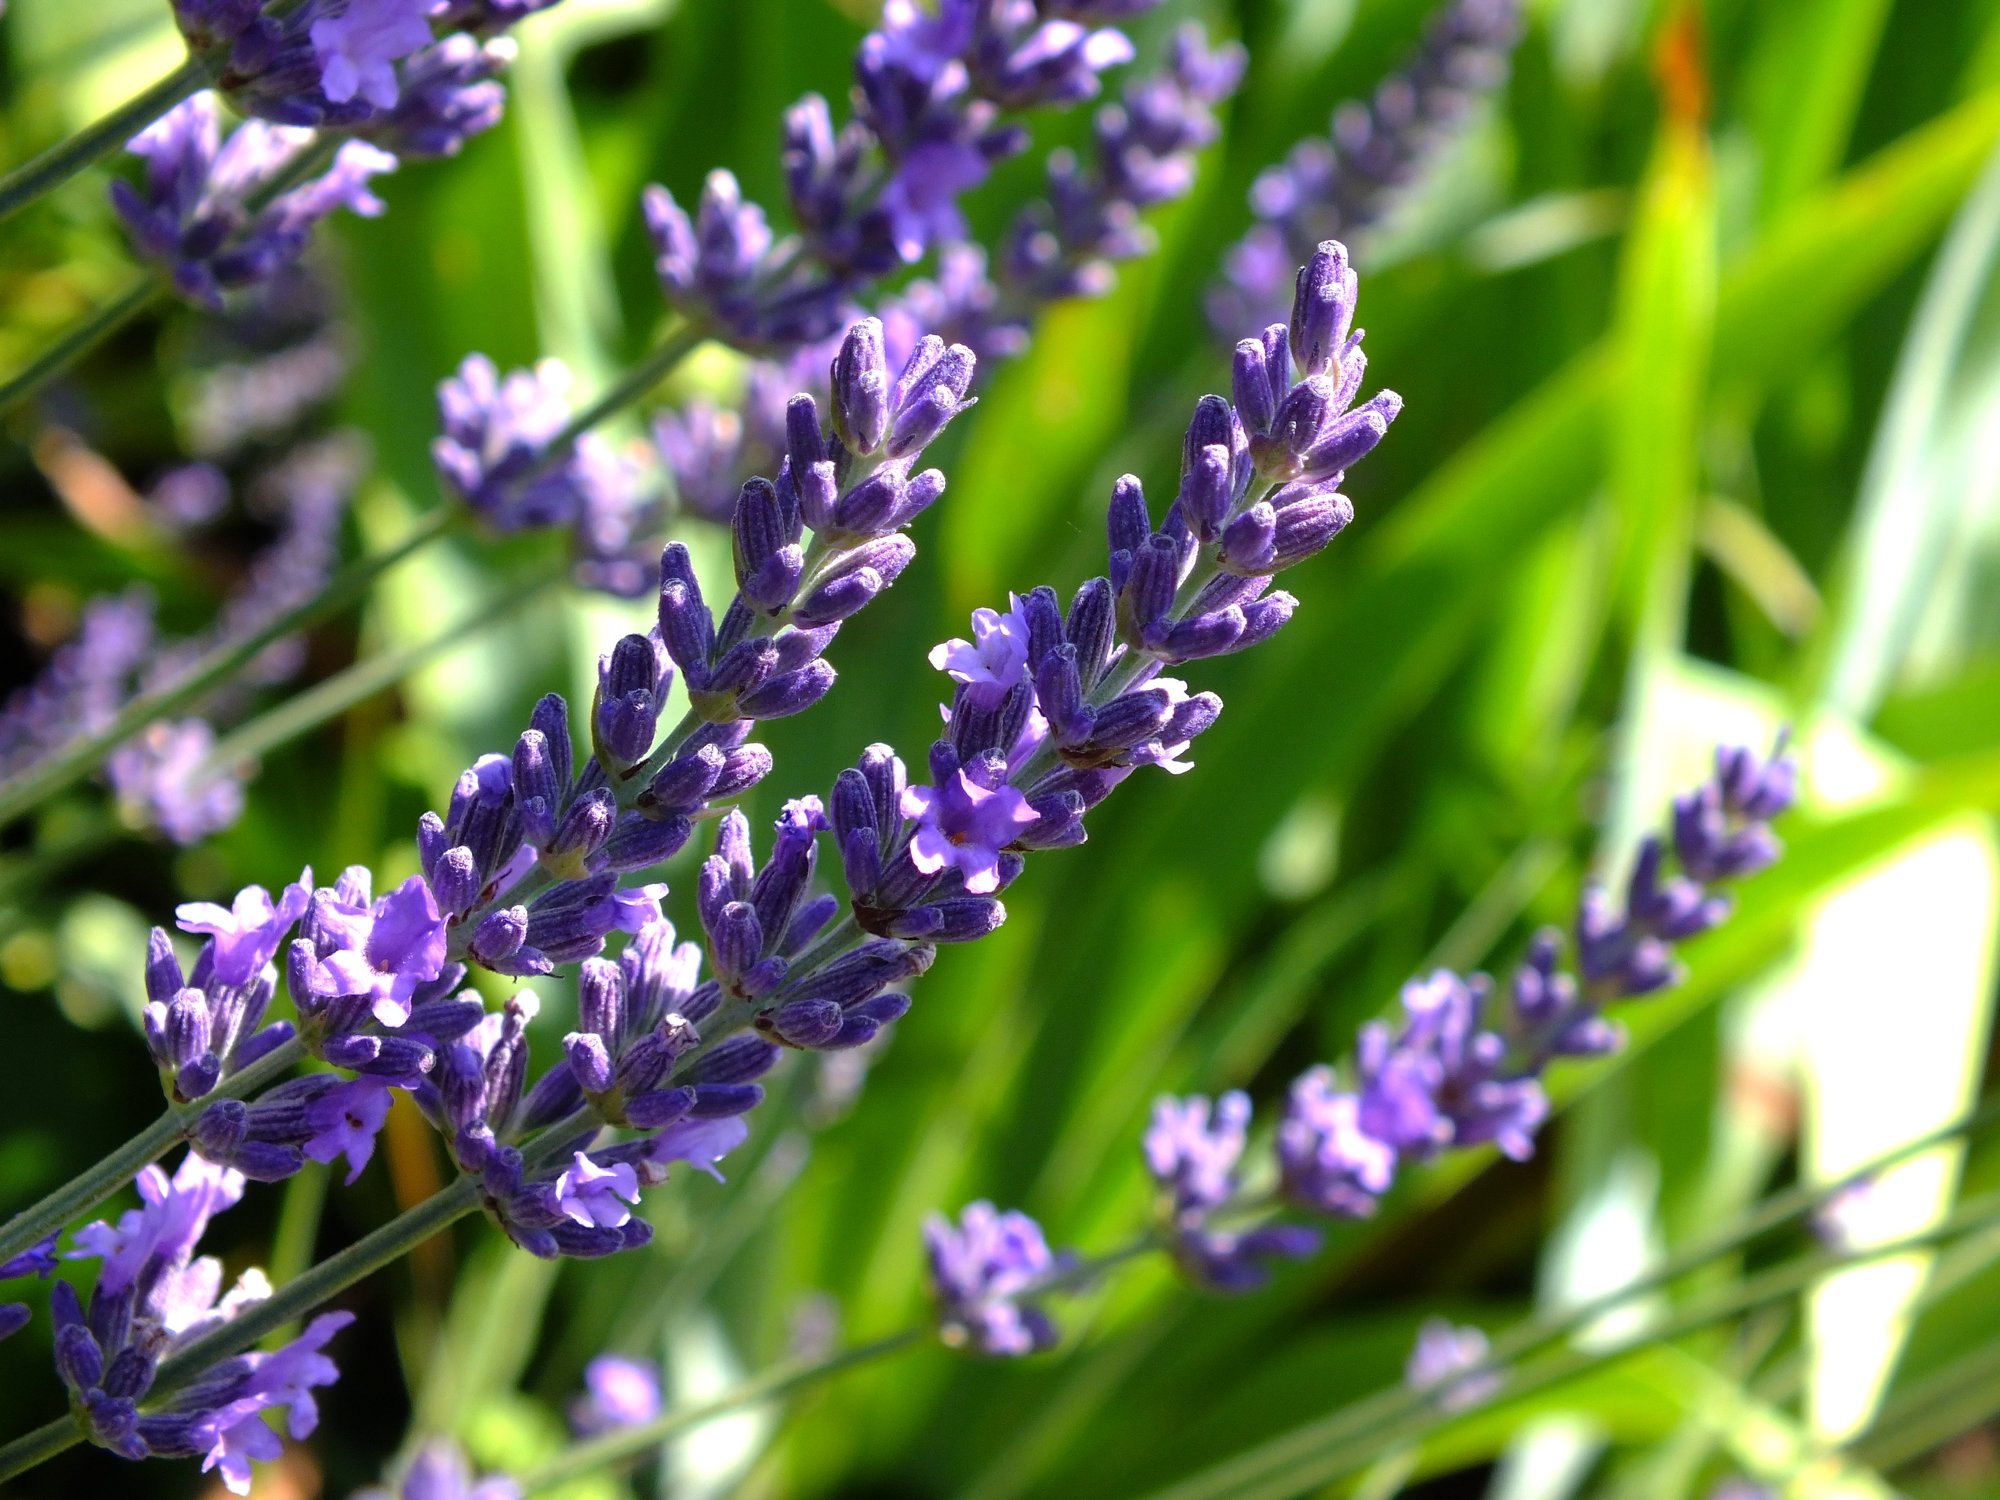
[924,1202,1068,1356]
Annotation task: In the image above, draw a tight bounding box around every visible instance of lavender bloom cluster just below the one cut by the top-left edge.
[112,92,396,308]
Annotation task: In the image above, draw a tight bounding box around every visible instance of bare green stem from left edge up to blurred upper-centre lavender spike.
[0,506,462,824]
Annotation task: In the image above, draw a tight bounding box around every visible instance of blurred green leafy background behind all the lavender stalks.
[0,0,2000,1500]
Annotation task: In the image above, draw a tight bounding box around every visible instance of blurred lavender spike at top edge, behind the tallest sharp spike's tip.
[1208,0,1520,334]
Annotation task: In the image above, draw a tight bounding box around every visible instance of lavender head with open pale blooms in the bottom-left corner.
[52,1154,352,1494]
